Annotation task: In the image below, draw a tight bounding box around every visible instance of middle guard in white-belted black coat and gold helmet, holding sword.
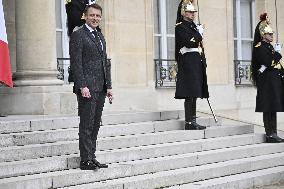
[175,0,209,130]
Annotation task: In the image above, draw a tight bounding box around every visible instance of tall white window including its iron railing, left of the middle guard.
[154,0,180,88]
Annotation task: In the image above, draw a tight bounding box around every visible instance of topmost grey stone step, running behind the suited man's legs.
[0,111,197,134]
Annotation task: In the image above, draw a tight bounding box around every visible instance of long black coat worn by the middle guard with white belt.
[175,21,209,99]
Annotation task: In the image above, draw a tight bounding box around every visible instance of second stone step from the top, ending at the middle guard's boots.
[0,120,222,147]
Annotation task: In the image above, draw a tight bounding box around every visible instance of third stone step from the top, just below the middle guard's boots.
[0,125,253,162]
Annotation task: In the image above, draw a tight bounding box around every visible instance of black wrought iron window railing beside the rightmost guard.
[234,60,252,86]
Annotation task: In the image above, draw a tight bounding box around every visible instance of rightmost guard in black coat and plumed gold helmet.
[251,13,284,143]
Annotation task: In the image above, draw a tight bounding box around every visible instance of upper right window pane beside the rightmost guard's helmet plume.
[240,0,252,38]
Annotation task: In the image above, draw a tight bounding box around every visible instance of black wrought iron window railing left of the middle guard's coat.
[154,59,177,88]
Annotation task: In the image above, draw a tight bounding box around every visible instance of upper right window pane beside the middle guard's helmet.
[166,0,180,34]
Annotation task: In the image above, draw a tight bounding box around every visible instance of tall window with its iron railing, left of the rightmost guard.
[234,0,255,85]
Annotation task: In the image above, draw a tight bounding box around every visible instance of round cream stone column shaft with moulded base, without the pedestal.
[14,0,63,86]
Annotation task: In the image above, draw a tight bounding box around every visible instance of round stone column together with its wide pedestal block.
[0,0,77,115]
